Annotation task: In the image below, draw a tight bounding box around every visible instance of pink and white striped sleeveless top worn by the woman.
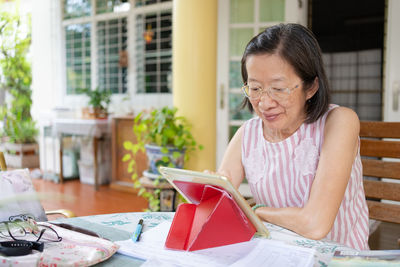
[242,105,369,250]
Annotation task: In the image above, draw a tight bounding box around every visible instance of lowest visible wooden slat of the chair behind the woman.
[367,200,400,226]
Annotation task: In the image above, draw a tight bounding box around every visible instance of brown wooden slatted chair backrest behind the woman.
[360,121,400,223]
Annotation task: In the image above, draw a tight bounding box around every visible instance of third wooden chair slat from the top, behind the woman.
[361,159,400,180]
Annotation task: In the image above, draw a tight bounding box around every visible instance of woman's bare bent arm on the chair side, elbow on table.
[256,107,360,239]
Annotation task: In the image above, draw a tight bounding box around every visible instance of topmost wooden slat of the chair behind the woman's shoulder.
[360,121,400,138]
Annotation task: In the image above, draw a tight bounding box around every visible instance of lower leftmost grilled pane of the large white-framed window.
[65,24,91,94]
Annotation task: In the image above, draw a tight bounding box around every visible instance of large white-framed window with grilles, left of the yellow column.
[62,0,172,95]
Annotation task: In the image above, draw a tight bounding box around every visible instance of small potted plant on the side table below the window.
[77,88,111,119]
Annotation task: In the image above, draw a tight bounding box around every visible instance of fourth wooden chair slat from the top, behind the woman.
[364,180,400,201]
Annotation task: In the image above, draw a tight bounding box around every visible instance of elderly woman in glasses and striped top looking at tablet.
[218,24,368,249]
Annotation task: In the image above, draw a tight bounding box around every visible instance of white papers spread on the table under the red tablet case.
[116,221,314,267]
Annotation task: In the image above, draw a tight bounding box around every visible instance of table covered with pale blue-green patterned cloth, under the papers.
[57,212,354,267]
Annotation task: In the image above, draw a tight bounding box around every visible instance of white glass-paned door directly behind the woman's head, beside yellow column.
[216,0,307,166]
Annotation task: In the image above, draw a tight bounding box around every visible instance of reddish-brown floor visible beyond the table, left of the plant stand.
[33,179,147,220]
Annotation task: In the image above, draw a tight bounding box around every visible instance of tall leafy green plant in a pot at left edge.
[0,12,39,168]
